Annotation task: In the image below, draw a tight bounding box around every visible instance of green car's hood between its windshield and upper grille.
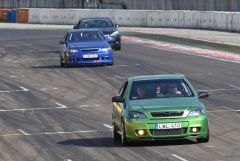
[128,97,202,112]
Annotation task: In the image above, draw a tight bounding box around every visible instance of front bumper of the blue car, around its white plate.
[67,51,113,65]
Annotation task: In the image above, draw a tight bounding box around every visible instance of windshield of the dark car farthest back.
[82,19,114,28]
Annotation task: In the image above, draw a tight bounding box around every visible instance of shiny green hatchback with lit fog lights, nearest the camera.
[112,74,209,145]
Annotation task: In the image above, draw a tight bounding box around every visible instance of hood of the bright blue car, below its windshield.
[67,41,109,48]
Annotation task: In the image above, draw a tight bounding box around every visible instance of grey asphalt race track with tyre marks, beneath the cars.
[0,29,240,161]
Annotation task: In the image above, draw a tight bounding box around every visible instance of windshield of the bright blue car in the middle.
[68,31,104,42]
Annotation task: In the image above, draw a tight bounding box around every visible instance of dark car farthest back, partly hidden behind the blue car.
[73,17,121,50]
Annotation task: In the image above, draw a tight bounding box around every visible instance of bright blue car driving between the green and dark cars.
[59,29,113,67]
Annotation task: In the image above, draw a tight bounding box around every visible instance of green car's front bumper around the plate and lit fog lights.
[124,115,208,141]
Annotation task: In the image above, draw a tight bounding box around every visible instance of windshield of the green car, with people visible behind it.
[129,79,194,100]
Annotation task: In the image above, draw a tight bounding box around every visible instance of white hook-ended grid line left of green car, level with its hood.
[0,103,68,112]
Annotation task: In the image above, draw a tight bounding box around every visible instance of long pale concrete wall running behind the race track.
[28,8,240,32]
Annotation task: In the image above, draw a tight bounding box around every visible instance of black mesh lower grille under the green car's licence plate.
[150,128,187,135]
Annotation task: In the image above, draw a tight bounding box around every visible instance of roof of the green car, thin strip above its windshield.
[128,74,185,81]
